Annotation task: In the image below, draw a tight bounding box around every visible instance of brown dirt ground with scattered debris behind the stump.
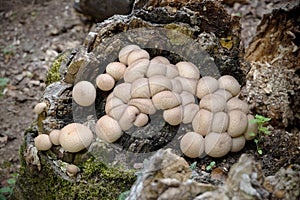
[0,0,296,195]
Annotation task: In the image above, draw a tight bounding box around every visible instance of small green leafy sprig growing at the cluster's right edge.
[250,115,271,155]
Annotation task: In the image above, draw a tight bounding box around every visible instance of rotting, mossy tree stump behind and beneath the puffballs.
[12,0,245,199]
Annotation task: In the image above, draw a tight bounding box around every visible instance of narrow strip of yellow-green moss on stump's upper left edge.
[46,51,70,85]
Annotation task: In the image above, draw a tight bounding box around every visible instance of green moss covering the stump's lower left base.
[11,131,136,199]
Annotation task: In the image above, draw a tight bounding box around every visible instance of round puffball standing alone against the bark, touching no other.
[72,81,96,106]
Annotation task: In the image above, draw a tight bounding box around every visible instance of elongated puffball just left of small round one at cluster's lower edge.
[119,106,140,131]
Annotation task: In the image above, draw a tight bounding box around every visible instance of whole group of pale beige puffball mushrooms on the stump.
[35,45,257,158]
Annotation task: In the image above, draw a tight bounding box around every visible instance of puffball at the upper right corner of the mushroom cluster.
[218,75,241,96]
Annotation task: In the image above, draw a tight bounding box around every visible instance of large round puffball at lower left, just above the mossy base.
[59,123,94,153]
